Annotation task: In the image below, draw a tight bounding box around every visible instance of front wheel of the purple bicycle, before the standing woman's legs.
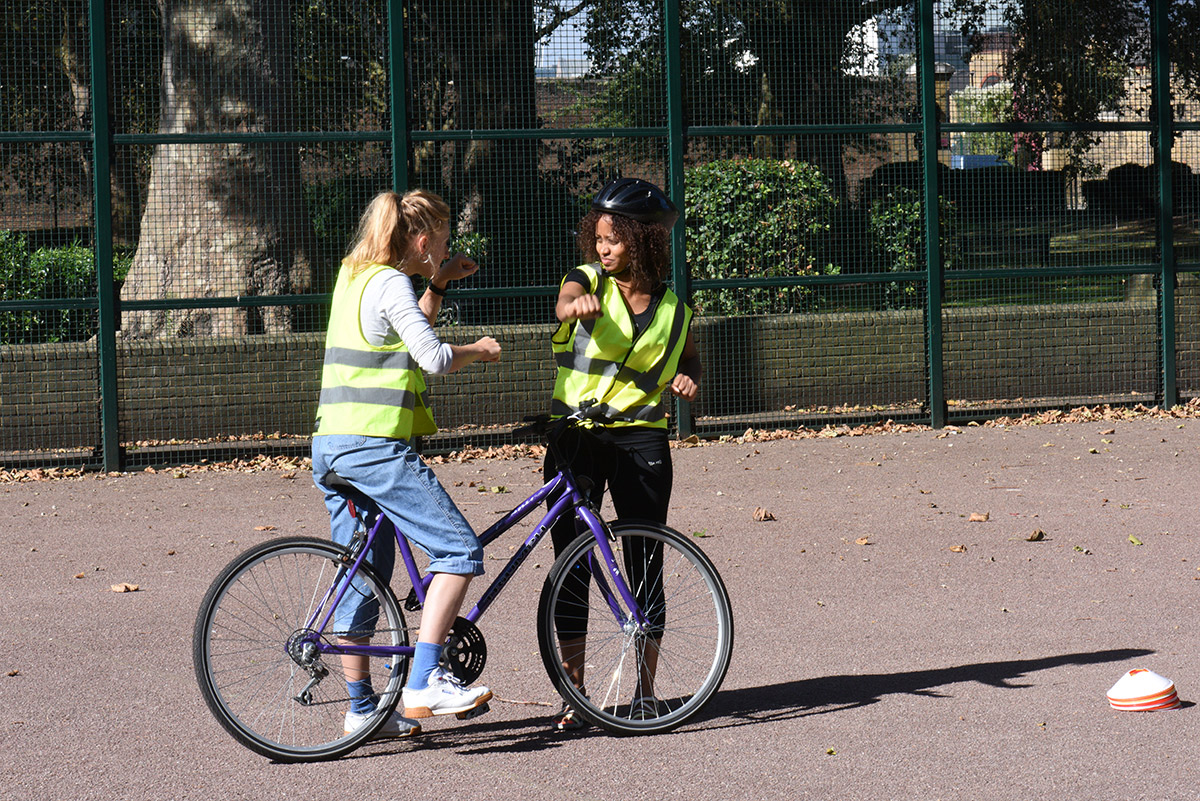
[538,520,733,734]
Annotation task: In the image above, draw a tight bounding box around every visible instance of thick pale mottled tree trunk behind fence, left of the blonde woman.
[121,0,312,338]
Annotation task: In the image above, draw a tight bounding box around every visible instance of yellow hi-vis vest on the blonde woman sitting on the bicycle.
[316,264,438,439]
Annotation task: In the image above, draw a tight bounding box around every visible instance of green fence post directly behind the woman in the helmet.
[662,0,695,439]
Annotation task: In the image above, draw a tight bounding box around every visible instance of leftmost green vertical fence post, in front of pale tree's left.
[88,0,121,472]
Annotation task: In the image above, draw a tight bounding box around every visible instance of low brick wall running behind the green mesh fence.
[0,297,1200,451]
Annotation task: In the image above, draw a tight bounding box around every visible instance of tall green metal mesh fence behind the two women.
[0,0,1200,470]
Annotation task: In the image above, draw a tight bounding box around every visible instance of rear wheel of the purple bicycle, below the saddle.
[192,537,408,761]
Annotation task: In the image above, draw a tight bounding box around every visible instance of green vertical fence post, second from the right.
[918,0,946,428]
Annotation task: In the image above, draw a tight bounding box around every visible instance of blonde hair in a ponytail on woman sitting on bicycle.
[346,189,450,275]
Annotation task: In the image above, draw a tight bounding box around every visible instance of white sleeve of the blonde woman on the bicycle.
[359,270,454,375]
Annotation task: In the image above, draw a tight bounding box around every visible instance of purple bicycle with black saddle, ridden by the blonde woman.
[193,411,733,761]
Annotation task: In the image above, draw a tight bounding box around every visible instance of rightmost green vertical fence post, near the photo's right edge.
[1150,0,1180,409]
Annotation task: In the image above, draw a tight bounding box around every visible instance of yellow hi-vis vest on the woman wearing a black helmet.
[551,264,691,428]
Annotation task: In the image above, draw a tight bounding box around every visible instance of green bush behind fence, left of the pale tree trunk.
[0,230,132,344]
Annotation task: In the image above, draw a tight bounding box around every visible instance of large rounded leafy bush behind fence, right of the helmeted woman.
[684,158,840,314]
